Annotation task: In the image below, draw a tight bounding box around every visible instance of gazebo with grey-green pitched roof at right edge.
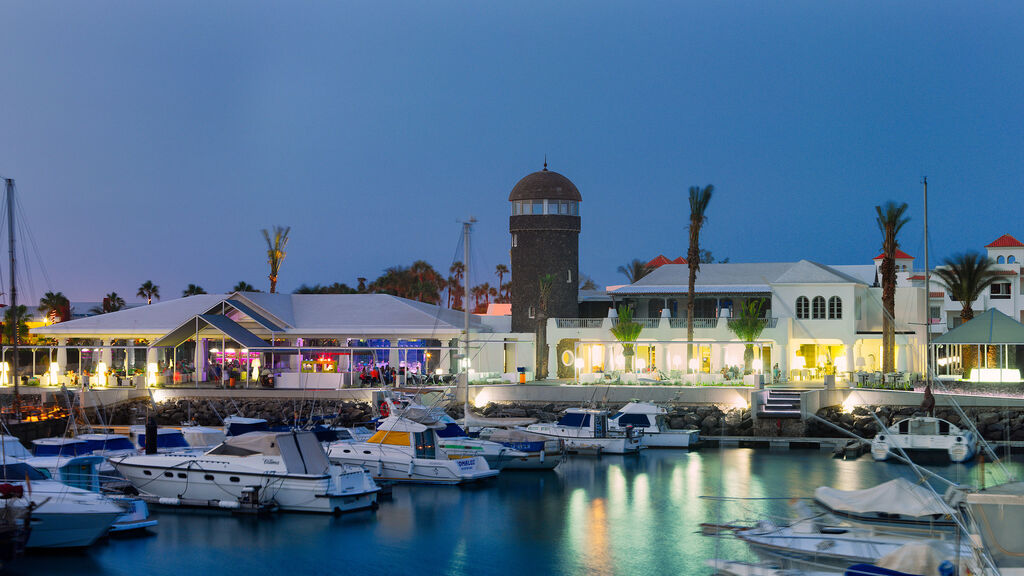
[930,308,1024,382]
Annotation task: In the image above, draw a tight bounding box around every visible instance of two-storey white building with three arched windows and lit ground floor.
[548,253,926,380]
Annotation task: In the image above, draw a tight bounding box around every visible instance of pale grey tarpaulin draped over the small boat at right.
[814,478,949,517]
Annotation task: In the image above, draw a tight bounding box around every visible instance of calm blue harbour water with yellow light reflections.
[18,448,1021,576]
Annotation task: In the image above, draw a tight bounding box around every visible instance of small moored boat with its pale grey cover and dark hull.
[814,478,956,530]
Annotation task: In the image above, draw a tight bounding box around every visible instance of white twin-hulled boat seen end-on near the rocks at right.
[871,416,978,462]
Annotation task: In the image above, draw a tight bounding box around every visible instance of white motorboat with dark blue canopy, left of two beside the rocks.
[523,408,643,454]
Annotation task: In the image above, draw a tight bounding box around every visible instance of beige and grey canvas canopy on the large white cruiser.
[207,431,331,475]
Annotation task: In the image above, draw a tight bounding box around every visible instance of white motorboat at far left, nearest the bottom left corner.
[2,459,125,548]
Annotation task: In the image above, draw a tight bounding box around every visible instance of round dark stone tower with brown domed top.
[509,162,583,332]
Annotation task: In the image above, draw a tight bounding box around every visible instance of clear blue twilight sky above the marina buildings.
[0,0,1024,300]
